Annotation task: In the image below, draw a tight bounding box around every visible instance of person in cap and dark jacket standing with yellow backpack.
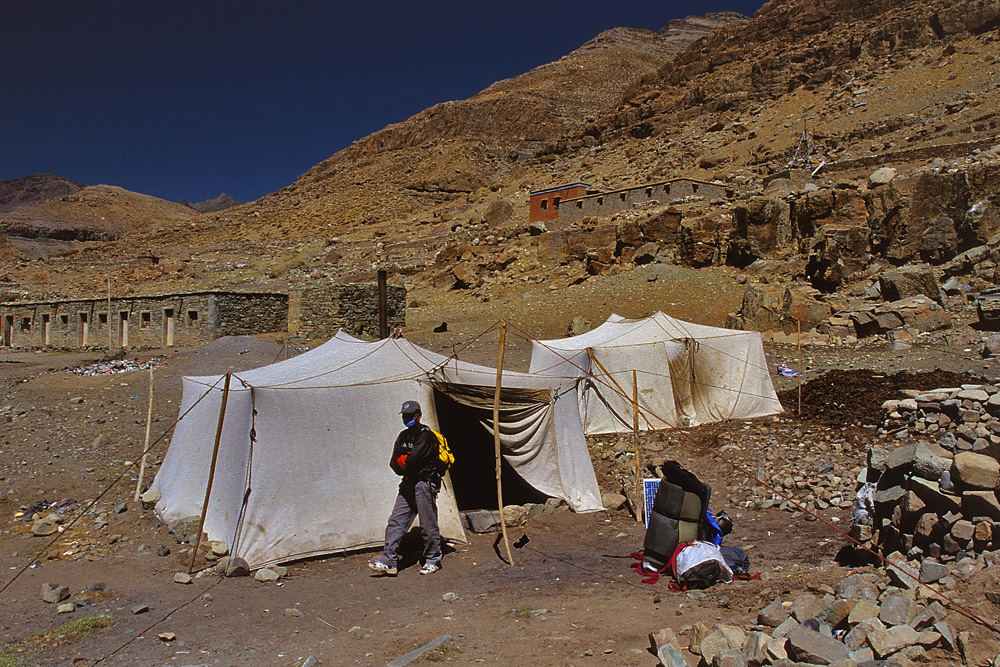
[368,401,441,577]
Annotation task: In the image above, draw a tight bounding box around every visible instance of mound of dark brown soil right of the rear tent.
[778,369,977,426]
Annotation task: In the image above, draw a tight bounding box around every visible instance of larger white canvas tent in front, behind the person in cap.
[151,333,601,568]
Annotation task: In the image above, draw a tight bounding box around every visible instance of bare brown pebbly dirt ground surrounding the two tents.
[0,272,997,666]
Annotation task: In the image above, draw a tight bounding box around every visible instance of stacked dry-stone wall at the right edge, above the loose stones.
[872,385,1000,560]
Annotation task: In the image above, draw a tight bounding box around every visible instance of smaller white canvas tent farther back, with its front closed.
[530,312,782,435]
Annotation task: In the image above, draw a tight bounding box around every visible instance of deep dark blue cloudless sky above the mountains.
[0,0,762,202]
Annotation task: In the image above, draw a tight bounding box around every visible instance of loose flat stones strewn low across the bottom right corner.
[650,552,1000,667]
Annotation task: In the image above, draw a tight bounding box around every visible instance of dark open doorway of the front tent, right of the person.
[434,383,547,510]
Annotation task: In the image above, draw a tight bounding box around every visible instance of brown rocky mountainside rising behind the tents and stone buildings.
[0,0,1000,324]
